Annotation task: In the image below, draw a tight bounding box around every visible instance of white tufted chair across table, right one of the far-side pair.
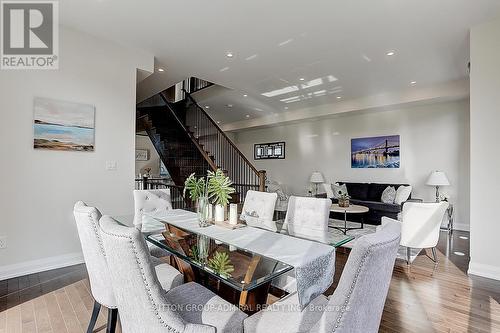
[272,196,332,293]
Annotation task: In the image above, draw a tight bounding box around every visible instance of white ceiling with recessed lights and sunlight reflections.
[60,0,500,124]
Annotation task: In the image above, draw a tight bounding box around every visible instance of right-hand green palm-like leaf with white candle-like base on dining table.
[207,169,235,222]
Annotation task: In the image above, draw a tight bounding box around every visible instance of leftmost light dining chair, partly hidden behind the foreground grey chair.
[73,201,184,333]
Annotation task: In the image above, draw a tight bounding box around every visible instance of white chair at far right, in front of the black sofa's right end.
[382,201,448,265]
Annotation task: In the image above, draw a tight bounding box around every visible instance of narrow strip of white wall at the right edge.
[469,19,500,280]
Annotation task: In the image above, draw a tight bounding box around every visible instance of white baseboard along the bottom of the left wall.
[0,252,84,281]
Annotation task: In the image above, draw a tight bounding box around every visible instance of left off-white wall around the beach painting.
[0,28,153,280]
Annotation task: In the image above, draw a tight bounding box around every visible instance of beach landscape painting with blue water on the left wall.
[34,98,95,151]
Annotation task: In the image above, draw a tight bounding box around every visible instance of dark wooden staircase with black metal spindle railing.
[136,78,266,202]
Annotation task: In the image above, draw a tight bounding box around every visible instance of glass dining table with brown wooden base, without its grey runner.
[113,210,354,312]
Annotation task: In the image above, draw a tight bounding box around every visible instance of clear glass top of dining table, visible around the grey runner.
[114,211,353,291]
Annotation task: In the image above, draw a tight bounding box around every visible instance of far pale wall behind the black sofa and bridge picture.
[236,100,469,230]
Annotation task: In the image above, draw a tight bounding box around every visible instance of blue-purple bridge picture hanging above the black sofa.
[351,135,400,168]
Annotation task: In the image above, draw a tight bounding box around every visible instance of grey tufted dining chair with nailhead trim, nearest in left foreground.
[100,216,247,333]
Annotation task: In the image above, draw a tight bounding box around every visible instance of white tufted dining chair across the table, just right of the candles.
[240,190,278,231]
